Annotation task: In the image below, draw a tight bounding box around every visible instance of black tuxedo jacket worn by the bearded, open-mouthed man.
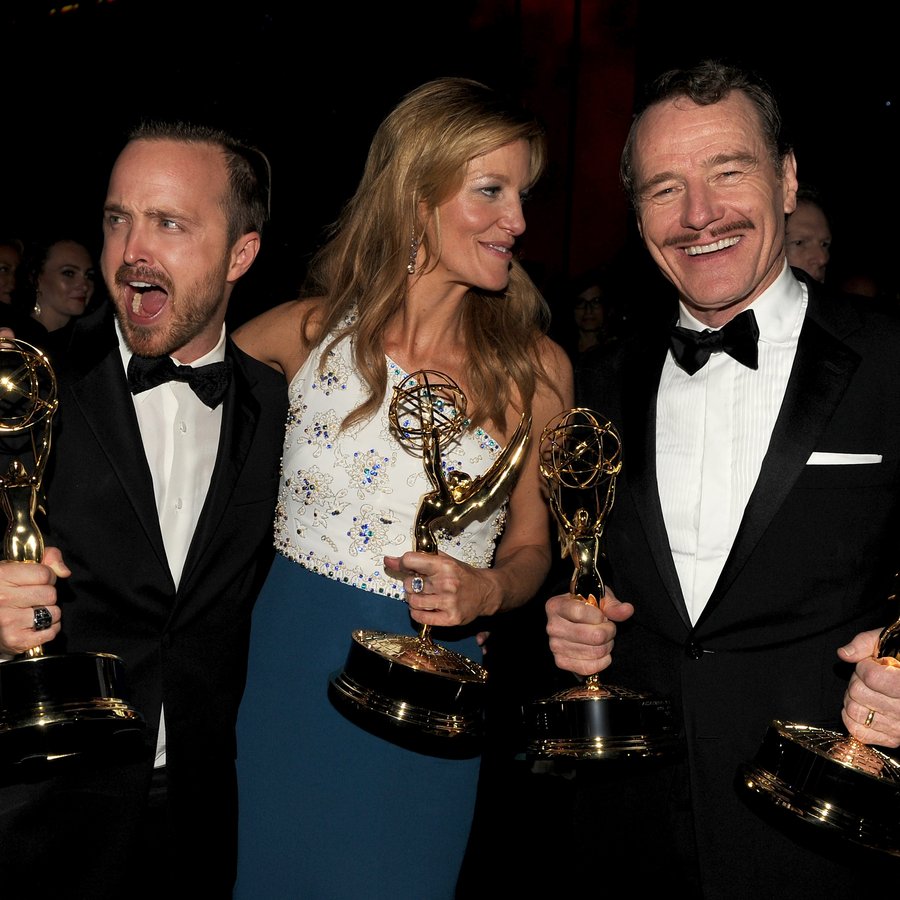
[0,307,287,896]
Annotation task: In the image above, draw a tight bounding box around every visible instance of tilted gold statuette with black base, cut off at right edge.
[736,592,900,856]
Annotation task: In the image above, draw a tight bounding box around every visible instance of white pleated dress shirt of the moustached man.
[656,264,808,623]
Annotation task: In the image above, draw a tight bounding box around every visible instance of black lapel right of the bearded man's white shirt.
[181,339,259,587]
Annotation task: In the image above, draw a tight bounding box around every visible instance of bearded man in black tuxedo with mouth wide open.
[0,123,287,900]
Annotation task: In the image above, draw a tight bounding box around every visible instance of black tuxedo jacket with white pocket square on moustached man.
[578,271,900,898]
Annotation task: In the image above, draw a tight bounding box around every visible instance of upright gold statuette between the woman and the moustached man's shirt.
[524,408,677,760]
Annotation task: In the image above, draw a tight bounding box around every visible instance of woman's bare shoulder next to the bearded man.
[233,298,321,381]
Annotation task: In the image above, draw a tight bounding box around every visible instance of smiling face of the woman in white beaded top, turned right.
[429,140,531,291]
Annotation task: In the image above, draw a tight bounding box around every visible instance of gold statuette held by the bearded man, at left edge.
[0,339,145,767]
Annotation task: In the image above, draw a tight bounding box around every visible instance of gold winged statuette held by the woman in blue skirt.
[328,370,531,756]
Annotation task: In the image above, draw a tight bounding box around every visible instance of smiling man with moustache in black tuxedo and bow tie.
[546,61,900,900]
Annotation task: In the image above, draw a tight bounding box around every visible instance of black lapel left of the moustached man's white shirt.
[613,335,690,628]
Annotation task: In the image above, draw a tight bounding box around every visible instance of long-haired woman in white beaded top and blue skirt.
[235,78,572,900]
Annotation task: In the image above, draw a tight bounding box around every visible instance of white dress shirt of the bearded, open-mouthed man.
[116,322,225,766]
